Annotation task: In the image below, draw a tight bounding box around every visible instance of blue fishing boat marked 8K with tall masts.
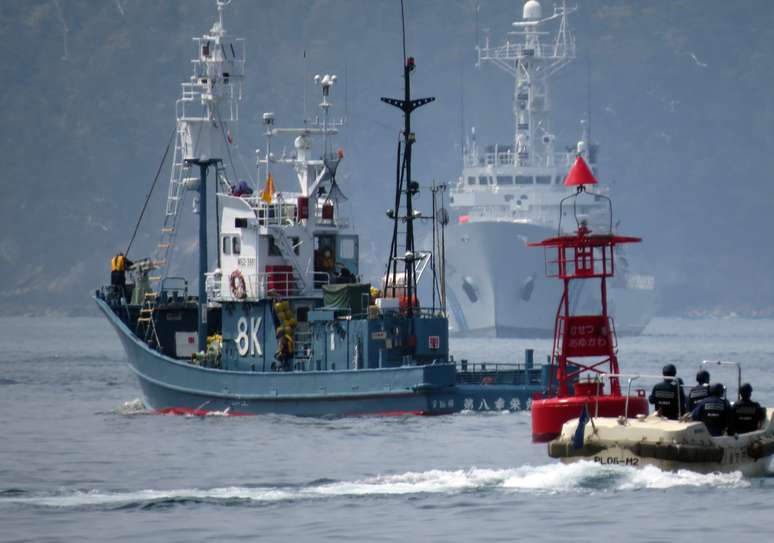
[95,0,548,416]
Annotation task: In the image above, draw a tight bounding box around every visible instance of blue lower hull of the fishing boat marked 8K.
[96,298,545,416]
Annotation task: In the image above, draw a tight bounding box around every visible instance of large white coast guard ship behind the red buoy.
[446,0,655,337]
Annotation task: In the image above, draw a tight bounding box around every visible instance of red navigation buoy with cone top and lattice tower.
[529,160,648,442]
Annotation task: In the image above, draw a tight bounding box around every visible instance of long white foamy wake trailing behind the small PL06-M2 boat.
[0,462,751,509]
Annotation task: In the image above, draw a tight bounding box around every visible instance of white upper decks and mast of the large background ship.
[450,0,608,228]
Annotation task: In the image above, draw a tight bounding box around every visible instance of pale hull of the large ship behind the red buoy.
[446,221,655,337]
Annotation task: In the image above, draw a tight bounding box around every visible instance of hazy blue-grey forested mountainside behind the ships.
[0,0,774,315]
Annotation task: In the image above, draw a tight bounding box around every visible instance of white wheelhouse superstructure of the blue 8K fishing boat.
[208,71,358,301]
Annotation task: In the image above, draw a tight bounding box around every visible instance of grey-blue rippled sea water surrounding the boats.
[0,318,774,543]
